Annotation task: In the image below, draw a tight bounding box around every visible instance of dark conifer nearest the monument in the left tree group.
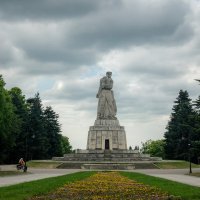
[44,106,62,158]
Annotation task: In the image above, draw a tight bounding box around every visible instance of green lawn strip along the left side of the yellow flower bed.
[0,172,95,200]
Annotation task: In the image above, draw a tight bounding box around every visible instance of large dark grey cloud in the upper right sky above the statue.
[67,1,192,50]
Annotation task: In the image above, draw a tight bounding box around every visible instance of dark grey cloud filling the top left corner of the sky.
[0,0,104,21]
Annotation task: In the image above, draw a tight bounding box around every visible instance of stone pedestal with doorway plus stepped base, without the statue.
[53,119,162,170]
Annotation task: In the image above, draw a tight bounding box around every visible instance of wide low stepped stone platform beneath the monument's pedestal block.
[52,149,162,170]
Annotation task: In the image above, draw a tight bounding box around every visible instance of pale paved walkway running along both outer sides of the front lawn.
[0,165,200,187]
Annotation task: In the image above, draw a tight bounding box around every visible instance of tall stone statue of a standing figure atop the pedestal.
[96,72,117,120]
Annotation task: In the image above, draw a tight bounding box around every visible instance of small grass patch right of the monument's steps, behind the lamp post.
[154,161,200,169]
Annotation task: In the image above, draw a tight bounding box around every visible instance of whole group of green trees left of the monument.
[0,75,72,163]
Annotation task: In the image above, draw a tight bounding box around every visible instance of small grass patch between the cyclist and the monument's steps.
[27,161,62,169]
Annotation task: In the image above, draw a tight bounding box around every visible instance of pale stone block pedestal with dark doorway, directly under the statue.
[87,119,127,150]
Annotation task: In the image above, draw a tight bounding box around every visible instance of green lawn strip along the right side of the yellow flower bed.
[120,172,200,200]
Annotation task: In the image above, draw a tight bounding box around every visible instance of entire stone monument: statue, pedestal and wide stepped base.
[54,72,157,170]
